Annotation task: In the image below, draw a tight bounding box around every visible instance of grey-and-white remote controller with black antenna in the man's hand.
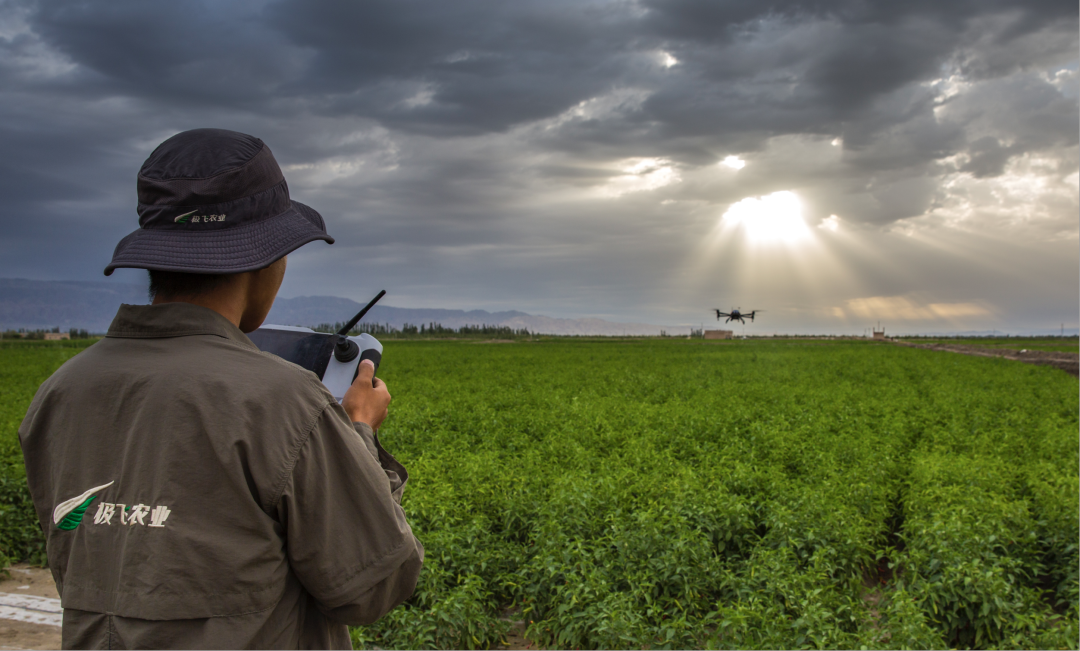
[247,290,387,403]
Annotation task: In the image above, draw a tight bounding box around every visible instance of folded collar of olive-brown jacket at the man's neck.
[105,303,258,350]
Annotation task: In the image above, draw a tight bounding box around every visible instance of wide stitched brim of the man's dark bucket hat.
[105,201,334,275]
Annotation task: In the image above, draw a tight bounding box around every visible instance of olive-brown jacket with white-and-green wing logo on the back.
[19,303,423,649]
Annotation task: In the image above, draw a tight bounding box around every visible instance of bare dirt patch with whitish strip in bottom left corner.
[0,564,60,649]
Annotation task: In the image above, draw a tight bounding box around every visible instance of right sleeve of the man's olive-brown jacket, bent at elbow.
[278,404,423,625]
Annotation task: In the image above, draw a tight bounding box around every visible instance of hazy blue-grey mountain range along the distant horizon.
[0,279,688,336]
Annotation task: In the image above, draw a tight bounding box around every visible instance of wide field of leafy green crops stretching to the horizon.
[0,339,1080,649]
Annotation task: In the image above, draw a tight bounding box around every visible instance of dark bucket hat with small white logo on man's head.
[105,128,334,275]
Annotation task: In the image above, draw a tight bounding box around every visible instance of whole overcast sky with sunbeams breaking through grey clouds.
[0,0,1080,333]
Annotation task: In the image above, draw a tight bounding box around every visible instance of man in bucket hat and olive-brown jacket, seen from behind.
[19,130,423,649]
